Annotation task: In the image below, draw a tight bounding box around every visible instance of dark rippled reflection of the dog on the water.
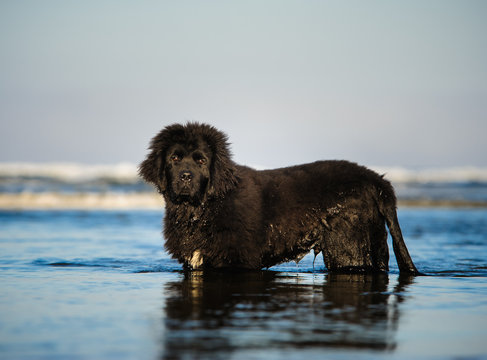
[163,271,412,359]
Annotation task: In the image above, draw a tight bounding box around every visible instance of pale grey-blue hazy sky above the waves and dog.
[0,0,487,168]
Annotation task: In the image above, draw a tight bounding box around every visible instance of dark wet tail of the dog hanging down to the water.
[380,187,420,275]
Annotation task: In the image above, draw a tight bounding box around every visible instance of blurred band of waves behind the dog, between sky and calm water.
[0,163,487,209]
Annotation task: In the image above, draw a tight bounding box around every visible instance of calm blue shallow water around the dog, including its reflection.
[0,208,487,360]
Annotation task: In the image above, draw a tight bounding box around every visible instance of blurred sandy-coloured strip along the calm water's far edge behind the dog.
[0,192,487,210]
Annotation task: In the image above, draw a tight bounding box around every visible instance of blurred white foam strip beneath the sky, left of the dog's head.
[0,163,139,182]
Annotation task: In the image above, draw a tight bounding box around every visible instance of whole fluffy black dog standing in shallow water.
[139,123,418,274]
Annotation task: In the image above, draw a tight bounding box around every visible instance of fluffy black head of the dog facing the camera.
[139,123,236,205]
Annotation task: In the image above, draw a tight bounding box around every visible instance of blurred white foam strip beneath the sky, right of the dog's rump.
[371,166,487,183]
